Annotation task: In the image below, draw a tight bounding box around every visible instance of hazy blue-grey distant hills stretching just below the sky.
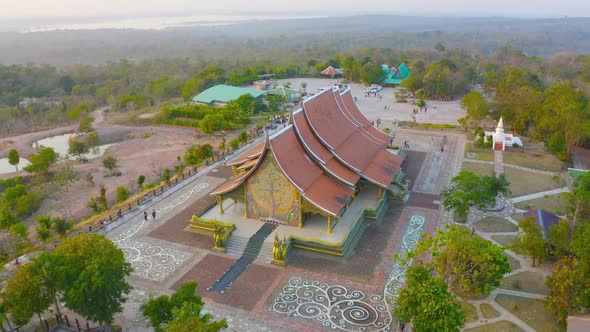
[0,15,590,66]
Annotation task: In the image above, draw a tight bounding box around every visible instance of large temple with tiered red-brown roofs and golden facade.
[192,88,407,254]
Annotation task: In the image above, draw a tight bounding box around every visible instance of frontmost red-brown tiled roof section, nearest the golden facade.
[270,126,354,216]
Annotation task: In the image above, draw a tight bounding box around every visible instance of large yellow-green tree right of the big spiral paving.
[414,226,510,297]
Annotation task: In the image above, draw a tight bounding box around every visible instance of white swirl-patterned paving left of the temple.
[113,183,209,282]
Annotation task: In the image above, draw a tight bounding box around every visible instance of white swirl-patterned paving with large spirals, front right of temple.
[269,215,426,332]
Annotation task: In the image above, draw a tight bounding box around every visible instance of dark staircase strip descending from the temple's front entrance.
[207,224,278,293]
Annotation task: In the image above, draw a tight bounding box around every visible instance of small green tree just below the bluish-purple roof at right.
[512,217,548,266]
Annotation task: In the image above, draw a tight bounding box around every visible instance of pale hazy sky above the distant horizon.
[0,0,590,18]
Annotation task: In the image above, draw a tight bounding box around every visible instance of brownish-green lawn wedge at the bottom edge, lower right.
[496,294,565,332]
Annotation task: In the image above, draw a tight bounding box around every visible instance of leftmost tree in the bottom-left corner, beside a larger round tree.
[5,263,53,325]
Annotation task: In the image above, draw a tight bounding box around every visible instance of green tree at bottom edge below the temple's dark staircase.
[140,282,227,331]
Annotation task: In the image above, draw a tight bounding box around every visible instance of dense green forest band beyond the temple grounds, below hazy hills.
[0,42,590,159]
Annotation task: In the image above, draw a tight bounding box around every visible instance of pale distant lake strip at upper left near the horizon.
[25,15,324,32]
